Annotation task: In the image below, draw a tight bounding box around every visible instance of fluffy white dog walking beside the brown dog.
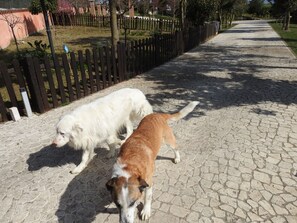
[53,88,153,174]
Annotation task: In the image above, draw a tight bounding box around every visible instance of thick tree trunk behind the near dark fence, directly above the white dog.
[109,0,120,47]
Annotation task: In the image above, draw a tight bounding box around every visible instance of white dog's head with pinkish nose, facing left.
[53,115,82,147]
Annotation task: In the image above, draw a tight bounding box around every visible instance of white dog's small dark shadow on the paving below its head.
[27,145,82,171]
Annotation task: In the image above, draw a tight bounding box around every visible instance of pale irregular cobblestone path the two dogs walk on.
[0,21,297,223]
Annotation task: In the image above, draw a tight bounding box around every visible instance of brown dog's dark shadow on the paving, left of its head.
[55,149,118,223]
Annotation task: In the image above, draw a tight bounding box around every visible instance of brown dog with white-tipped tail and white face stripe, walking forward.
[106,101,199,223]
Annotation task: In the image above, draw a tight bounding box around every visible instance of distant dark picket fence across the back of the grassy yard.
[52,13,180,32]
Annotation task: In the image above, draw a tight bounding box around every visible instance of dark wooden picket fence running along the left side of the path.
[0,23,216,122]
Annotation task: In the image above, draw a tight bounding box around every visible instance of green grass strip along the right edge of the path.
[269,22,297,56]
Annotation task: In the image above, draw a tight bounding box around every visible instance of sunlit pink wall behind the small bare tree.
[0,10,45,49]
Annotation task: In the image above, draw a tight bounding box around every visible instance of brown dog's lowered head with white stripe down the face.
[106,176,149,223]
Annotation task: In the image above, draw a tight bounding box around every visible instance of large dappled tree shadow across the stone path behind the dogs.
[144,45,297,115]
